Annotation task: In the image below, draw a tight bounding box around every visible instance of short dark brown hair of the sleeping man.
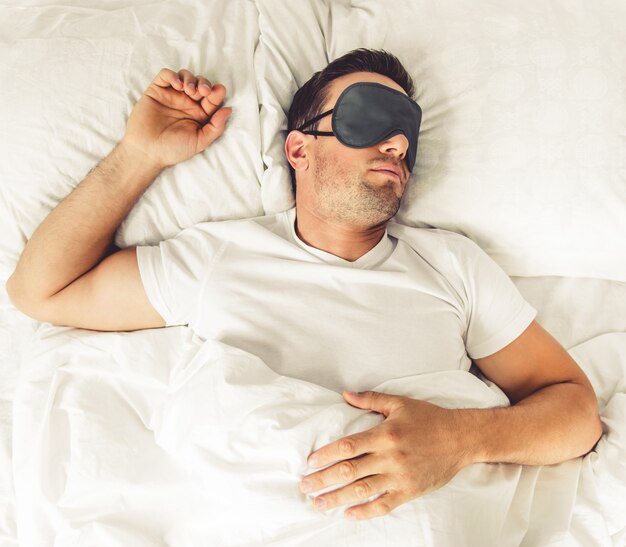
[285,48,415,196]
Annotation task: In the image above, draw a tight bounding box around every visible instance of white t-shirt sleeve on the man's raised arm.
[136,223,224,327]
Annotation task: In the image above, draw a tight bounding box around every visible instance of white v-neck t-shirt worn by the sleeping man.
[137,209,536,392]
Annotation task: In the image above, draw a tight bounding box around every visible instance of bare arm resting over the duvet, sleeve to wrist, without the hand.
[456,321,602,465]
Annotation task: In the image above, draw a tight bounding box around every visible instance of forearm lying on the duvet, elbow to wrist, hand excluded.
[455,382,602,465]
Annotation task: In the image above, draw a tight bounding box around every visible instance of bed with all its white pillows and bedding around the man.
[0,0,626,547]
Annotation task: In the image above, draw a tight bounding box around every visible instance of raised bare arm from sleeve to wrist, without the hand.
[6,144,164,330]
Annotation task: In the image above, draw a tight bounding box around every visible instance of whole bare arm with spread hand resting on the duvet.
[301,321,602,519]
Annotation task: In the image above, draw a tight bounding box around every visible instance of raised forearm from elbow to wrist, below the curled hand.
[7,143,161,300]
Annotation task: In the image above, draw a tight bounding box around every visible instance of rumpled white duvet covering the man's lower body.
[13,326,626,547]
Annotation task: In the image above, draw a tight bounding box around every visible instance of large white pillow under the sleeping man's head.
[256,0,626,281]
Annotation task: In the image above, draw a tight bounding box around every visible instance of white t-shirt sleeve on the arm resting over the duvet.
[448,234,537,359]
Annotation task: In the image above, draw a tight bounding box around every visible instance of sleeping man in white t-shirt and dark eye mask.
[7,50,602,519]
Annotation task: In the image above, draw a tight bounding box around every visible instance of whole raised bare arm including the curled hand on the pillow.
[6,68,232,331]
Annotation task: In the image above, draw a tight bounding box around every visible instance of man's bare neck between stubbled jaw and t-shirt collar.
[295,203,387,262]
